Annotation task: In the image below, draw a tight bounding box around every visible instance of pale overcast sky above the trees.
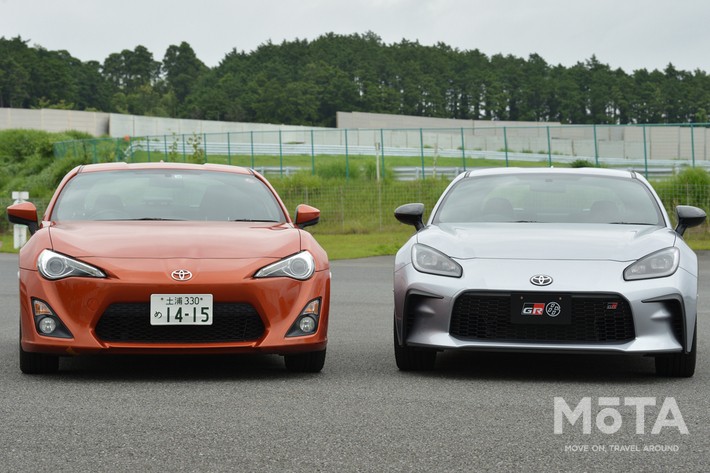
[0,0,710,73]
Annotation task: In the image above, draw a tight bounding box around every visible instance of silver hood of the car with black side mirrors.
[417,223,677,261]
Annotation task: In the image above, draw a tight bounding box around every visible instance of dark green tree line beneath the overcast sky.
[0,32,710,127]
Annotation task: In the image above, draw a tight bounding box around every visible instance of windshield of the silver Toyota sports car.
[434,173,664,225]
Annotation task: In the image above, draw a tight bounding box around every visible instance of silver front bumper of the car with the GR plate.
[394,259,697,354]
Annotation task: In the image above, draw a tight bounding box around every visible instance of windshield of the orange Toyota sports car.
[51,169,285,222]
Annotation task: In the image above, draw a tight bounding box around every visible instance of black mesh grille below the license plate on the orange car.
[96,302,264,343]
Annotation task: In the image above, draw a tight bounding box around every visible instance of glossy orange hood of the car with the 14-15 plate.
[49,221,301,259]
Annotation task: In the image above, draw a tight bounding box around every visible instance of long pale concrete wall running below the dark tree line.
[0,108,710,162]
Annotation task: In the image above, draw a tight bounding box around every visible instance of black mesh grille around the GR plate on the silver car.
[449,293,636,342]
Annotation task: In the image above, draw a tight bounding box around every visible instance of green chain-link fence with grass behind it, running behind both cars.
[5,125,710,243]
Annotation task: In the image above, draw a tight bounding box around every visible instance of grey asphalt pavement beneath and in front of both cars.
[0,253,710,472]
